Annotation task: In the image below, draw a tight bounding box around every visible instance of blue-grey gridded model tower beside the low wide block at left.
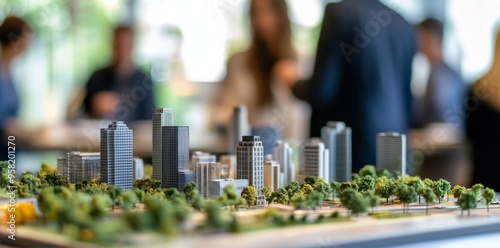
[101,121,133,189]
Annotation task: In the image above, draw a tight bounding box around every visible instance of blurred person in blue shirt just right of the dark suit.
[414,18,466,128]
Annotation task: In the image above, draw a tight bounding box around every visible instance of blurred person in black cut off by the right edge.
[465,27,500,191]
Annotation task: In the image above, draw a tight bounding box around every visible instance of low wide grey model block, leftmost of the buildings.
[57,151,101,183]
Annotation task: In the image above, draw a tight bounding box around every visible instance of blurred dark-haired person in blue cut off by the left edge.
[0,16,31,161]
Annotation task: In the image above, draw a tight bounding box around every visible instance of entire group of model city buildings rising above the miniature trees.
[57,106,406,198]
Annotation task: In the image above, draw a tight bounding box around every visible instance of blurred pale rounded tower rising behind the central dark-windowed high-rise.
[229,105,251,155]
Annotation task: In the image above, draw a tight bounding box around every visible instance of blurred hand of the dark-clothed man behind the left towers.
[92,91,120,119]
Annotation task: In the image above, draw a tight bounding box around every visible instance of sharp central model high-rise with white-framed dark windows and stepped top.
[236,136,264,194]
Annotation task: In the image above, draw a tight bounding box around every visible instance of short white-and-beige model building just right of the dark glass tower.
[194,162,228,199]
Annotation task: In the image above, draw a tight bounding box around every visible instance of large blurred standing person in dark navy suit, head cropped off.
[293,0,416,171]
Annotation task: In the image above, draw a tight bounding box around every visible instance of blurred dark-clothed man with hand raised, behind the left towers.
[83,26,155,123]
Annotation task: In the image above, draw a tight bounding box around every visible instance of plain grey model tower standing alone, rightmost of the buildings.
[377,132,406,176]
